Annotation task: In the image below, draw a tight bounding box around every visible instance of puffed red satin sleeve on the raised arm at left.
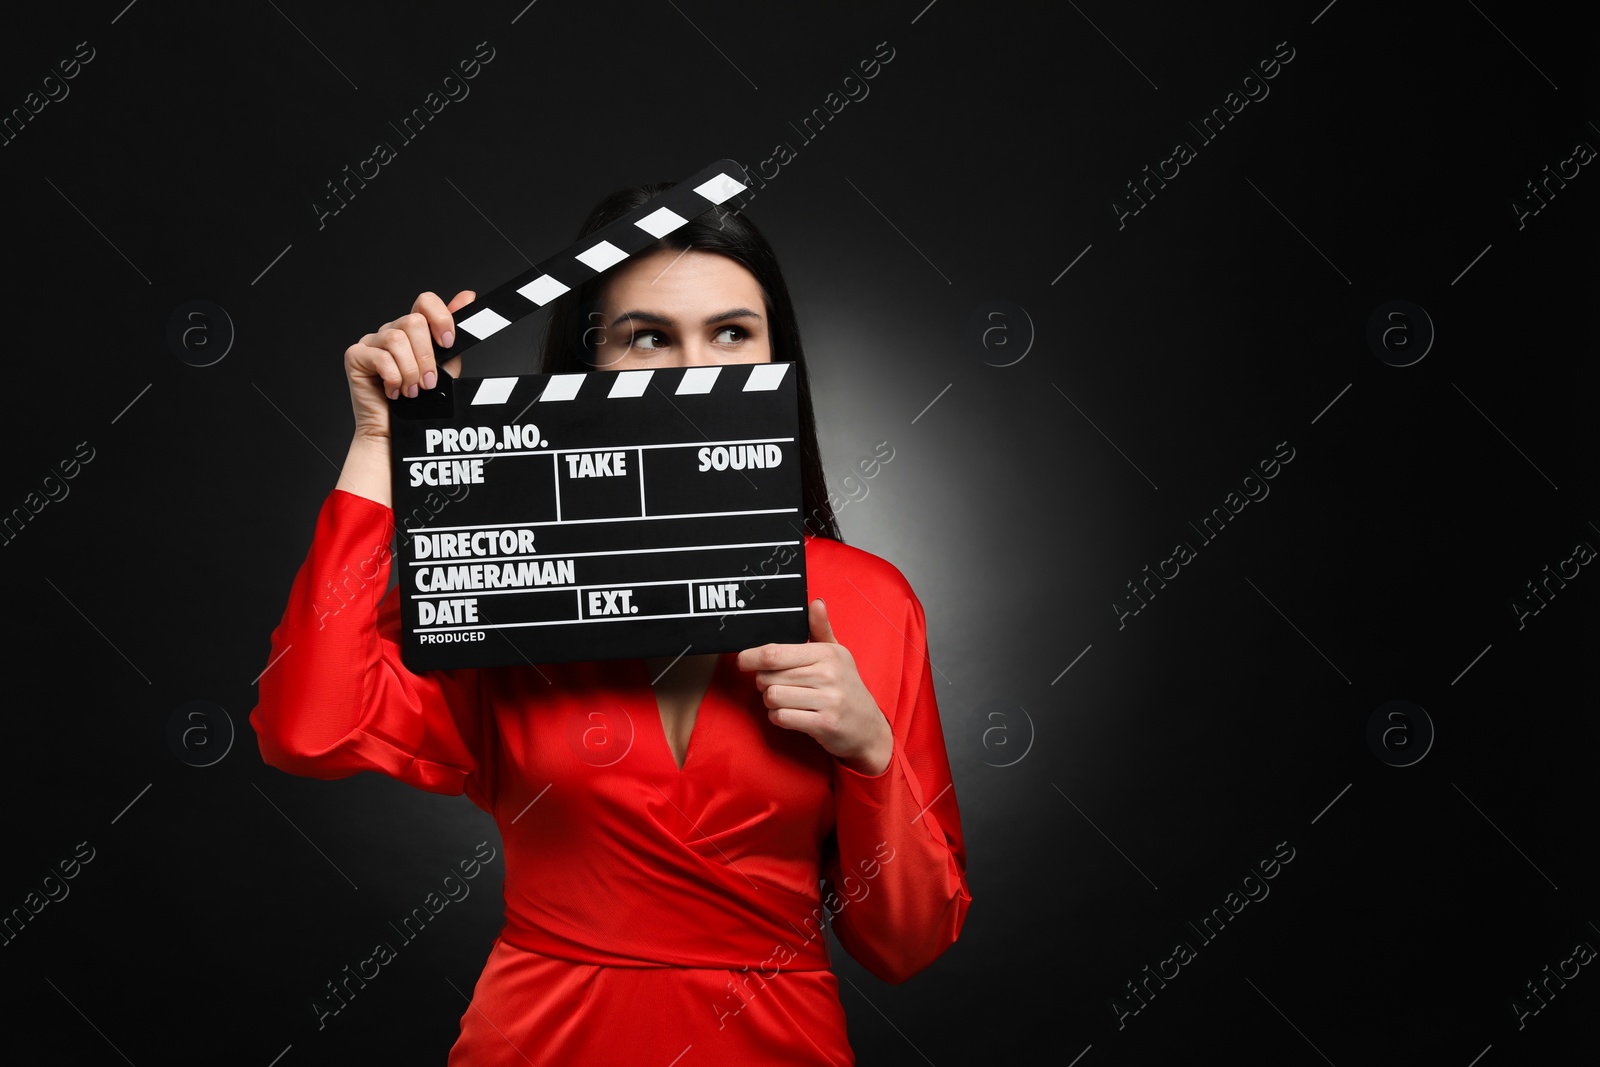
[250,490,491,809]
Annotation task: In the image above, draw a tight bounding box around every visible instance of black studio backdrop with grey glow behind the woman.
[0,0,1600,1067]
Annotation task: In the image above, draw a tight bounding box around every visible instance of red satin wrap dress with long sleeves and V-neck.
[250,490,971,1067]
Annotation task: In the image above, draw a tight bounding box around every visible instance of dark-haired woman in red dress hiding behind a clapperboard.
[251,186,971,1067]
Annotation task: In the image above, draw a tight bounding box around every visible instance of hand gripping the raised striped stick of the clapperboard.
[344,290,477,446]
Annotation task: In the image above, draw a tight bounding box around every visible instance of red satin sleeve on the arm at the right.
[822,585,971,984]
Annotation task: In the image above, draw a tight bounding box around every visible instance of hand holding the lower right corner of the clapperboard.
[739,600,894,776]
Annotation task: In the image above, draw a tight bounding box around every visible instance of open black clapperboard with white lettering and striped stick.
[390,160,808,670]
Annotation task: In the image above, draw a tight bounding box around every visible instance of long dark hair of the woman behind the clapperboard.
[539,182,843,542]
